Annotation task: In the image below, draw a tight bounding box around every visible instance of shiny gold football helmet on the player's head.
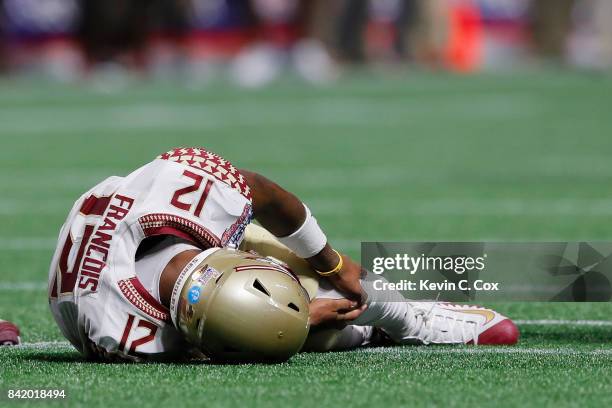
[173,249,309,361]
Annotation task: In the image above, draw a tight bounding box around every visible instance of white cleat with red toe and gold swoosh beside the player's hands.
[402,302,519,345]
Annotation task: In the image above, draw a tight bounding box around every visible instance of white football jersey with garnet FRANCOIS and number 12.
[49,148,252,359]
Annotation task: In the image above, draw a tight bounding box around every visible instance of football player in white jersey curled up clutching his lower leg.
[49,148,518,360]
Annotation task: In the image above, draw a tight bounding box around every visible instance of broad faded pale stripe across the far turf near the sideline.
[0,95,540,134]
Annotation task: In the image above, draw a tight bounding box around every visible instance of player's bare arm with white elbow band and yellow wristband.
[240,170,365,302]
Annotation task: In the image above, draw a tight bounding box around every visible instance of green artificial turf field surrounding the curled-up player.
[0,72,612,407]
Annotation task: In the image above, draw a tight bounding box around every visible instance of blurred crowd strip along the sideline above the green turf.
[0,0,612,87]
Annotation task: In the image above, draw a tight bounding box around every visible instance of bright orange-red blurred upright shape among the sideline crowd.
[446,0,484,72]
